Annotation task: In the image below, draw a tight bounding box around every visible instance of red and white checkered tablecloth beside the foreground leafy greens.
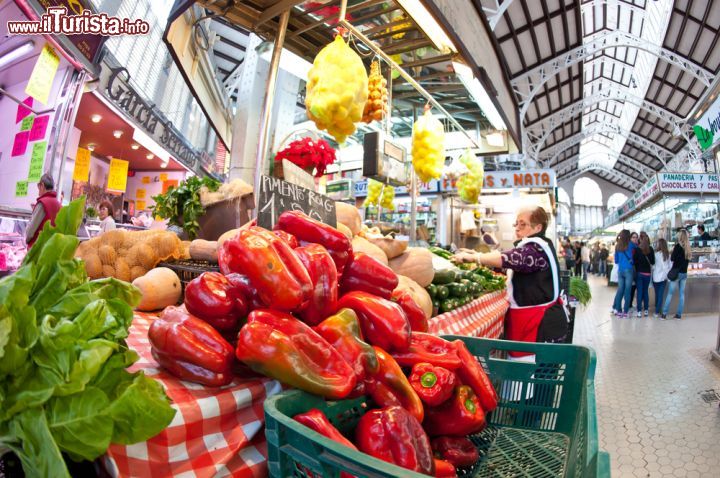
[105,314,281,478]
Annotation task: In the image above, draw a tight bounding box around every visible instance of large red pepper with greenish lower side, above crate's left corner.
[235,309,356,399]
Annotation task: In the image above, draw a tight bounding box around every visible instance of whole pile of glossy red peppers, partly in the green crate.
[149,211,497,477]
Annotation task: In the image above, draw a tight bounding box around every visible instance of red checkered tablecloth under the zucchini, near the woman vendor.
[429,290,510,339]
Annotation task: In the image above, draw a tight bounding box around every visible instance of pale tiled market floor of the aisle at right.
[574,276,720,478]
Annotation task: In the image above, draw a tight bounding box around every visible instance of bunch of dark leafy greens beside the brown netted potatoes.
[153,176,220,240]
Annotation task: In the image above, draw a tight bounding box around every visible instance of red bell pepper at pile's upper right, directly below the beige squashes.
[340,252,396,298]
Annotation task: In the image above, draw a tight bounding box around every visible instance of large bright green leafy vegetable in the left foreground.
[0,199,175,477]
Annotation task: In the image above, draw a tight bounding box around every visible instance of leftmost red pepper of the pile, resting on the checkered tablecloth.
[148,307,233,387]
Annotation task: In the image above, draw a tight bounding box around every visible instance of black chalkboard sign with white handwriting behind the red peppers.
[258,176,337,229]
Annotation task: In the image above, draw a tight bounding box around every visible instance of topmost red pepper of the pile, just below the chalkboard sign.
[275,211,353,276]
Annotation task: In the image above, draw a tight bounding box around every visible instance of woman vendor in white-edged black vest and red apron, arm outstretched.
[453,207,568,357]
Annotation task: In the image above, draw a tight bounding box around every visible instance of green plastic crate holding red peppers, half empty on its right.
[265,336,610,478]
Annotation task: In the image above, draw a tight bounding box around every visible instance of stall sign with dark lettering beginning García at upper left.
[100,63,211,172]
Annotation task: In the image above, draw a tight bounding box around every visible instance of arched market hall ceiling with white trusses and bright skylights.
[474,0,720,190]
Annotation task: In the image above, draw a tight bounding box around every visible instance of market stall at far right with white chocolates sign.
[605,173,720,313]
